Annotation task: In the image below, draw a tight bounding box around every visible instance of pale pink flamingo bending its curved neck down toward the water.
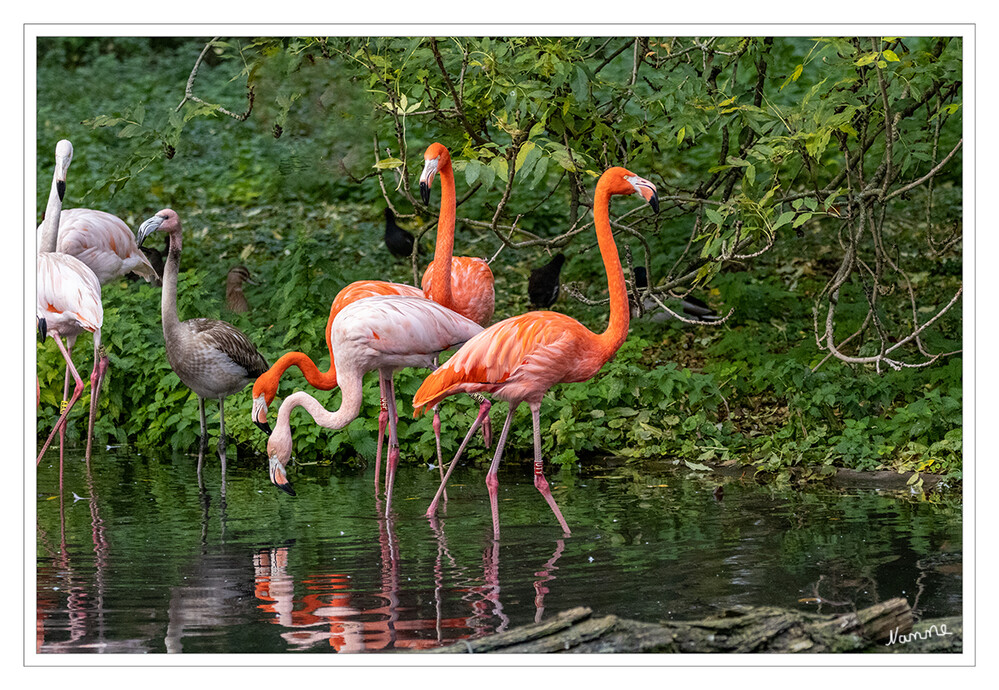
[267,295,482,516]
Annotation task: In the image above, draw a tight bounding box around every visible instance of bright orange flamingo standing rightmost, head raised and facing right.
[413,167,659,539]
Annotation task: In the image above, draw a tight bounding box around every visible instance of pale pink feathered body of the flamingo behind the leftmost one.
[44,208,157,283]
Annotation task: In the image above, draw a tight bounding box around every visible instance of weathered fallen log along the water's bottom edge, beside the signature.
[425,598,962,654]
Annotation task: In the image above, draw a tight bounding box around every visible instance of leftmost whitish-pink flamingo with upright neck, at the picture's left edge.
[35,139,108,468]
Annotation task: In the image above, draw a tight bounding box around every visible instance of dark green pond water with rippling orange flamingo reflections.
[36,449,963,653]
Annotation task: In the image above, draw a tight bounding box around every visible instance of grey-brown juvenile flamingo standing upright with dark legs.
[138,209,267,462]
